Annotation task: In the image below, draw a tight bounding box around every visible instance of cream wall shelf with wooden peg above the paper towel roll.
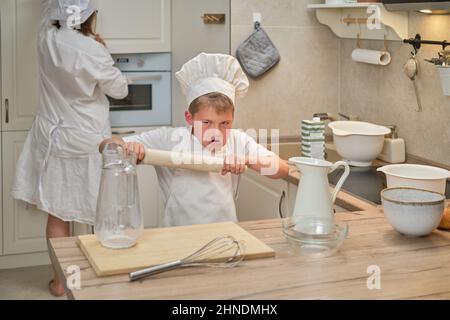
[308,2,408,41]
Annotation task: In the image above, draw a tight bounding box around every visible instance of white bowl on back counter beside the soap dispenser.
[328,121,391,167]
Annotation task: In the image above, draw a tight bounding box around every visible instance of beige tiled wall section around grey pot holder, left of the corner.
[231,0,339,139]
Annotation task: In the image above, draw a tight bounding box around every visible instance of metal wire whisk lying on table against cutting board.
[129,235,245,281]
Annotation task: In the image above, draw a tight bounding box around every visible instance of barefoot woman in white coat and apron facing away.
[12,0,128,296]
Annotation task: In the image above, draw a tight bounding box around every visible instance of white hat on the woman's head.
[50,0,96,27]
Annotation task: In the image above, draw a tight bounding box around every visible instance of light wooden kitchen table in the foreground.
[50,209,450,300]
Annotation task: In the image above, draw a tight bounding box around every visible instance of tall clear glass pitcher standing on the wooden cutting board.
[94,143,144,249]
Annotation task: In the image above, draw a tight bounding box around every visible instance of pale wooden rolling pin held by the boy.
[142,149,224,173]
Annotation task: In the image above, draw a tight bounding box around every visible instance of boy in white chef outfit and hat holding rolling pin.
[100,53,289,226]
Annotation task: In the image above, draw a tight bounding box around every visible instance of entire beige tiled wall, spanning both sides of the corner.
[231,0,450,165]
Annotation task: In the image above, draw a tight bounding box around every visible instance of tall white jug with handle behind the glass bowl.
[289,158,350,222]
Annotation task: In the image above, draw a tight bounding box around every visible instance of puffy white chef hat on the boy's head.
[176,53,249,106]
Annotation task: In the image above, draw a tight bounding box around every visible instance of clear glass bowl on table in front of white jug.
[282,216,348,258]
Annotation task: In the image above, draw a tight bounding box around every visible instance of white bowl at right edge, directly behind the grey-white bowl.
[377,164,450,194]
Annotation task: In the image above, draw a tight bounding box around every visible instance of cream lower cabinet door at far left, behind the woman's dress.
[2,132,47,255]
